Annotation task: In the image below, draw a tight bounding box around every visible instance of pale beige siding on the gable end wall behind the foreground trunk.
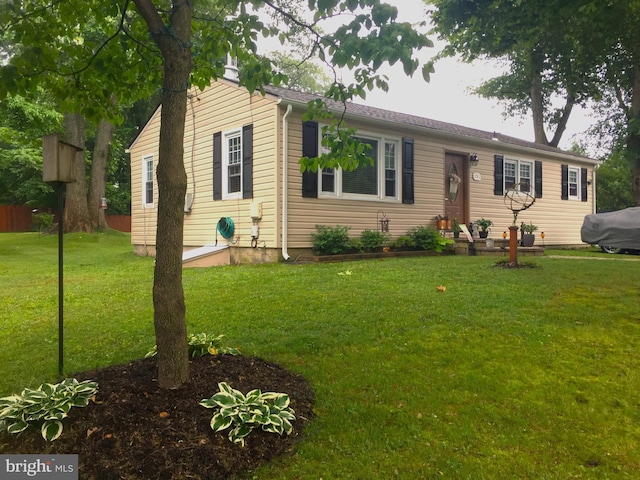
[131,81,279,255]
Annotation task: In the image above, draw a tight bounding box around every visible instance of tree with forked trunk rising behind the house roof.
[425,0,598,146]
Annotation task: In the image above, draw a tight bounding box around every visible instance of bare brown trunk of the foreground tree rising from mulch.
[134,0,192,388]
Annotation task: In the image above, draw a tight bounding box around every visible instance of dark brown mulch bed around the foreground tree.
[0,355,314,480]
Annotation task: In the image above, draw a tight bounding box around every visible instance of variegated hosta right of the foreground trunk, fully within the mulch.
[200,382,296,446]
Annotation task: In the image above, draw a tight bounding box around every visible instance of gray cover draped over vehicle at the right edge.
[580,207,640,249]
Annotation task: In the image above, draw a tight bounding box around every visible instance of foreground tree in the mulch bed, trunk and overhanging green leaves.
[0,0,431,388]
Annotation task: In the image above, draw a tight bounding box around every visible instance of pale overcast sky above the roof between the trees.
[308,0,589,149]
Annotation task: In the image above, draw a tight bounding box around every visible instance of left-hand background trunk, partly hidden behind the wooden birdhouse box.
[63,113,91,232]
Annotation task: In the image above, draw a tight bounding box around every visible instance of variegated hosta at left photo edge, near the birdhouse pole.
[0,378,98,442]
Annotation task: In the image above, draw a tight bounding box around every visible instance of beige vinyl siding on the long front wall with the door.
[288,106,594,248]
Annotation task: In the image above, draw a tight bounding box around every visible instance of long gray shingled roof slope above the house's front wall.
[265,86,589,160]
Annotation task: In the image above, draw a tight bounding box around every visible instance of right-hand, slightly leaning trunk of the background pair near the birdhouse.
[87,116,115,230]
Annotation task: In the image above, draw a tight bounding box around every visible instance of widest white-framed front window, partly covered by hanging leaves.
[318,133,402,201]
